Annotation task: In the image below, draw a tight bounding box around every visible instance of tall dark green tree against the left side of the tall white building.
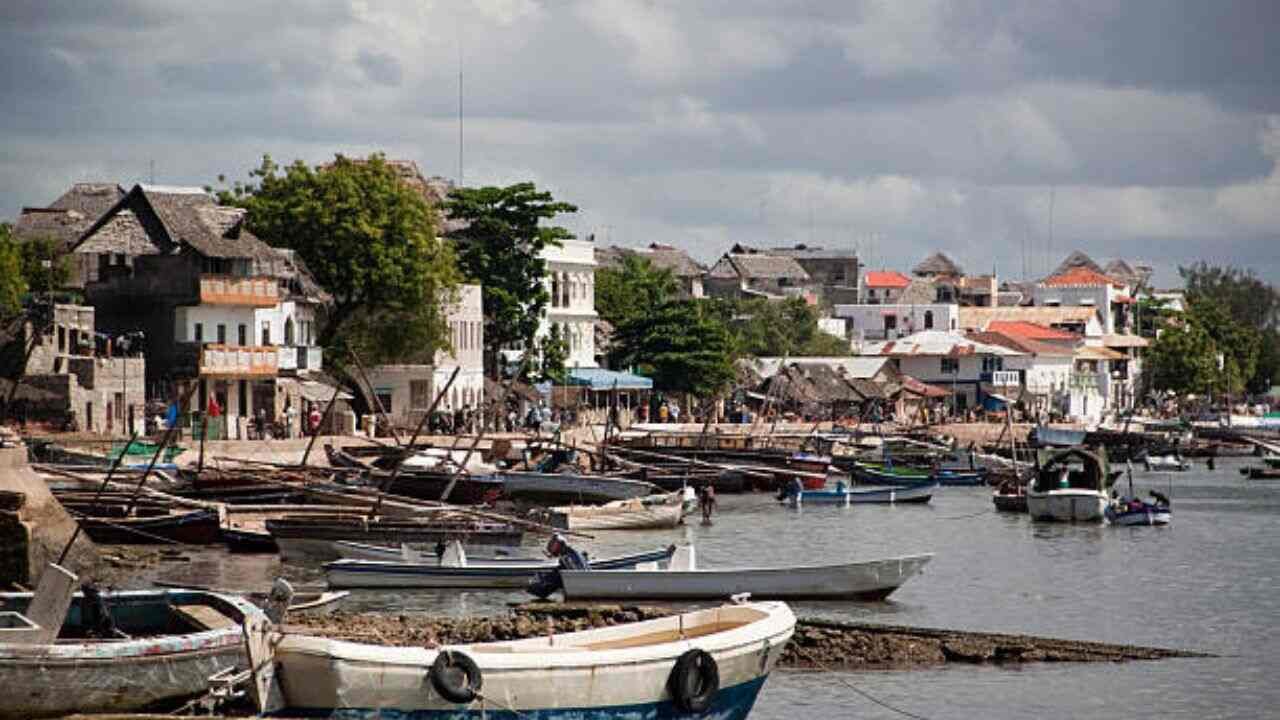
[444,182,577,377]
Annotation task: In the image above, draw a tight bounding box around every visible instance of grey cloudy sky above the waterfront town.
[0,0,1280,284]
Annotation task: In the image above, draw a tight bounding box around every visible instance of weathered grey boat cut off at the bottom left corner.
[0,586,262,719]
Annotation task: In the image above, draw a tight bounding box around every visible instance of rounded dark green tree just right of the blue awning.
[611,300,733,397]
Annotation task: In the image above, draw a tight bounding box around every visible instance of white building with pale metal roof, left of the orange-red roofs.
[861,331,1023,411]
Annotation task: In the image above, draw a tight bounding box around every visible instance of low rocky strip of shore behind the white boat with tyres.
[285,602,1213,671]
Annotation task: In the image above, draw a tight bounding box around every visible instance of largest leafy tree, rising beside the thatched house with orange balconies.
[219,154,458,363]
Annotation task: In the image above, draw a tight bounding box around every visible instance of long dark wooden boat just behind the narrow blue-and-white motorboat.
[265,515,525,560]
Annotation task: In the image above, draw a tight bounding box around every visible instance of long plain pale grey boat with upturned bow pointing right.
[559,555,933,601]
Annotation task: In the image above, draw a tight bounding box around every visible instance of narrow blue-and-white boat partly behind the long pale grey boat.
[324,546,676,589]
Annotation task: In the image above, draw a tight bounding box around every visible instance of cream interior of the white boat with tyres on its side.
[467,606,768,653]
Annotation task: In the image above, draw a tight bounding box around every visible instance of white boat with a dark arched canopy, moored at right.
[1027,448,1110,523]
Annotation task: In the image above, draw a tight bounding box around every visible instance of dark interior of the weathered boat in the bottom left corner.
[0,591,243,643]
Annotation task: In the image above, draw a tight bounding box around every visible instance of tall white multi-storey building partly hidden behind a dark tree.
[535,240,596,368]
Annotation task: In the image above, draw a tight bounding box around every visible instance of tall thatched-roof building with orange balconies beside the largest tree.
[73,186,326,438]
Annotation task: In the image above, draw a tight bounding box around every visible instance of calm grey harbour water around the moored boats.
[140,461,1280,720]
